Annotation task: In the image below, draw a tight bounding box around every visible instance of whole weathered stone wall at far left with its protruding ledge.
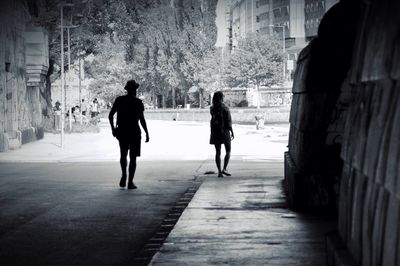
[0,0,49,151]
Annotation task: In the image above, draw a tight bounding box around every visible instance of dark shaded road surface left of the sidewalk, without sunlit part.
[0,161,206,265]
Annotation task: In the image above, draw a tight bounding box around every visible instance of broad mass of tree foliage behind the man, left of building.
[31,0,218,106]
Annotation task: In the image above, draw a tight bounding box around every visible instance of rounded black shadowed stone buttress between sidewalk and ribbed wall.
[285,2,357,210]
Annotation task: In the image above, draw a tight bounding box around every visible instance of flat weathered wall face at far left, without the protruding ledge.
[0,0,29,151]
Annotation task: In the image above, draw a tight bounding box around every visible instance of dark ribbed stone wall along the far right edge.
[338,0,400,265]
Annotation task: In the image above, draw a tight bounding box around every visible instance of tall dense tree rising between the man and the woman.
[124,0,216,107]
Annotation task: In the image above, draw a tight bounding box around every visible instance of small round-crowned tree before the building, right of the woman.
[224,33,283,108]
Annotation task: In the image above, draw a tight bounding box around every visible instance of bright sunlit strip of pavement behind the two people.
[0,119,289,162]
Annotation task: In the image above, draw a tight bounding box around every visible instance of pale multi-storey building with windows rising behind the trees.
[225,0,339,81]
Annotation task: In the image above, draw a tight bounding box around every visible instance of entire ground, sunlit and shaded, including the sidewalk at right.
[0,121,334,266]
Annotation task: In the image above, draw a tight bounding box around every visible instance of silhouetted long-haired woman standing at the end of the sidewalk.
[210,91,235,177]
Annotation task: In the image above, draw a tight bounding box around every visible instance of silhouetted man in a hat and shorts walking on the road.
[108,80,149,189]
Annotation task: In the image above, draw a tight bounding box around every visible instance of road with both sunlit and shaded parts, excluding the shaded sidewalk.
[0,121,288,265]
